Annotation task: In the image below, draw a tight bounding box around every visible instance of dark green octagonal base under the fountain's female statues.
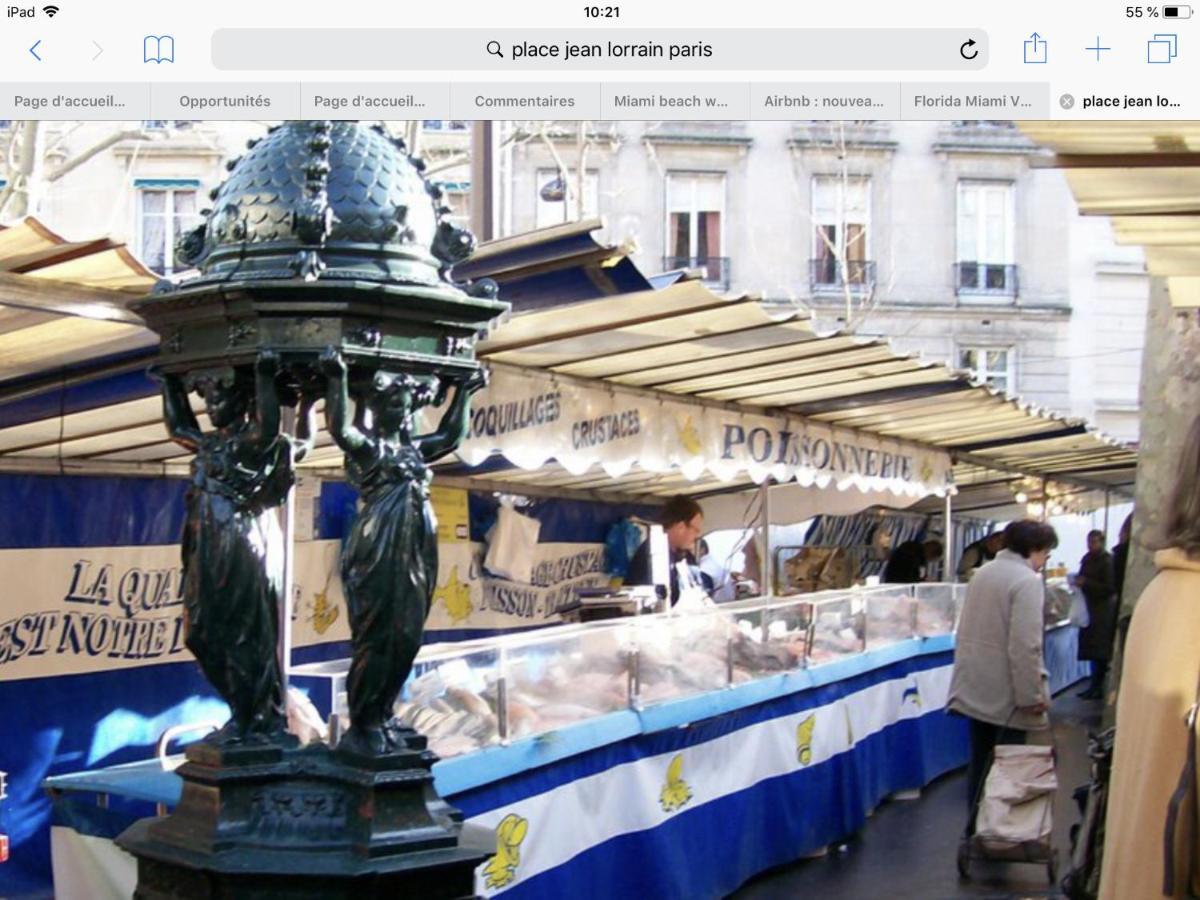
[118,734,494,900]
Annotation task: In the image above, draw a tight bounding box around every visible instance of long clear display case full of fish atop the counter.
[293,584,965,757]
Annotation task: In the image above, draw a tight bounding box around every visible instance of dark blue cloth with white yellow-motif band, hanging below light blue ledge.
[451,652,966,900]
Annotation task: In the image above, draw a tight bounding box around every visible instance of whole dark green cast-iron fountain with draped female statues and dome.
[120,121,506,900]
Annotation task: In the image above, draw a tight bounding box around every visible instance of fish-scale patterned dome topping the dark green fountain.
[176,121,474,288]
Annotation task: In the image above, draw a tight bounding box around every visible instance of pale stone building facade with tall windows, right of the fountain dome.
[503,121,1148,439]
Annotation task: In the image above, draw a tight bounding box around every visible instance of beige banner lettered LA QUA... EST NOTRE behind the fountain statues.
[0,540,608,680]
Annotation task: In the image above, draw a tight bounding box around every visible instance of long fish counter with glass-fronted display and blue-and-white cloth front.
[47,584,967,899]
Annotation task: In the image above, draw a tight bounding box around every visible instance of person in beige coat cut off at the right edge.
[1100,419,1200,900]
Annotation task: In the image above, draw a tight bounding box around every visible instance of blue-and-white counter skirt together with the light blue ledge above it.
[42,637,966,900]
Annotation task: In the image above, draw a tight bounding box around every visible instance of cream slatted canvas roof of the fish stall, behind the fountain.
[0,222,1136,511]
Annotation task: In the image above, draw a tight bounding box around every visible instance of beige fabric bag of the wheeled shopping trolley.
[976,744,1058,844]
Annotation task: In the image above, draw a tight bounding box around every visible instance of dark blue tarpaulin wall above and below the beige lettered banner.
[0,472,648,895]
